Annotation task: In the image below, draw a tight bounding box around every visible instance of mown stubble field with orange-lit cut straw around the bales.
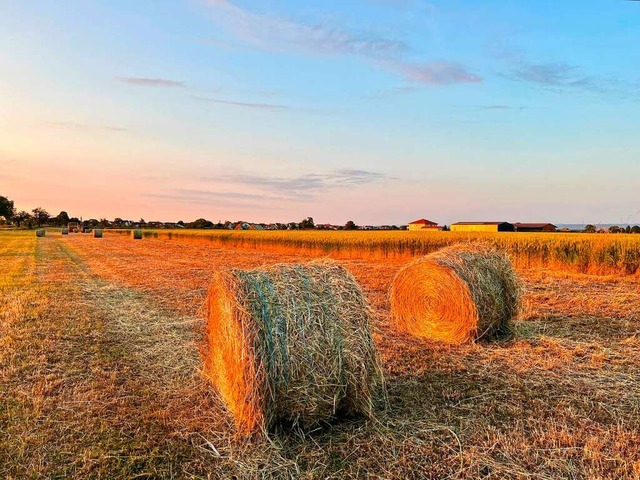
[0,232,640,478]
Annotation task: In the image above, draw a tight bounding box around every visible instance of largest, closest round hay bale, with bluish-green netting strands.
[204,261,385,435]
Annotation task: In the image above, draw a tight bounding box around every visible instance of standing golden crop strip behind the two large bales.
[115,230,640,275]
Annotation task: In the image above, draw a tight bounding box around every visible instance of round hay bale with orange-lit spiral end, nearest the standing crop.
[390,244,520,344]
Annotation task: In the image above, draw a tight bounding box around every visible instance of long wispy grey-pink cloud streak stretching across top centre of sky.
[202,0,482,85]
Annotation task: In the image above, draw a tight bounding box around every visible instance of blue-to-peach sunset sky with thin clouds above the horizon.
[0,0,640,224]
